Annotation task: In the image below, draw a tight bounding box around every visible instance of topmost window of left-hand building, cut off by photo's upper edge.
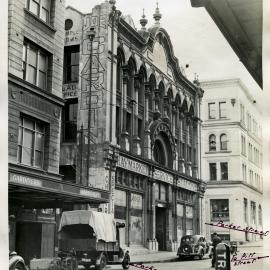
[26,0,51,23]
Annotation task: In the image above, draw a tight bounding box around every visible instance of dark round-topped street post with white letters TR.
[215,243,231,270]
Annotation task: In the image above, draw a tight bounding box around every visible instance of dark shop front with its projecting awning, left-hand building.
[9,165,109,265]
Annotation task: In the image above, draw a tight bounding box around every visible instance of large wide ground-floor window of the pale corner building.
[210,199,229,220]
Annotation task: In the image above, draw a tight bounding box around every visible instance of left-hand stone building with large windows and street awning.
[8,0,109,264]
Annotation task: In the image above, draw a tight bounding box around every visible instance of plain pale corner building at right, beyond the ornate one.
[201,79,263,242]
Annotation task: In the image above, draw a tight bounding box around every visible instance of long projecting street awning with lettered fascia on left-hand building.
[8,170,109,208]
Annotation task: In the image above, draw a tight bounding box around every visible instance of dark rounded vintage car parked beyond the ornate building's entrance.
[177,235,209,260]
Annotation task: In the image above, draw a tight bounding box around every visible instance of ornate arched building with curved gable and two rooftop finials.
[60,0,204,250]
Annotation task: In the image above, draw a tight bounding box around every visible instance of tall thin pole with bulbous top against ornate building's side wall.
[87,27,96,184]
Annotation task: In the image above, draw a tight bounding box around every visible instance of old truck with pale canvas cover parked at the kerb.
[58,210,125,270]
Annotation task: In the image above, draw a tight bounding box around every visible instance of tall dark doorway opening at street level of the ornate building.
[156,207,166,250]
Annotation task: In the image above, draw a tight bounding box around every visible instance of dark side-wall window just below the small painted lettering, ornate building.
[63,98,78,142]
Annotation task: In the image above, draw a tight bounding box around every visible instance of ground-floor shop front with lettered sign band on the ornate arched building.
[114,154,199,251]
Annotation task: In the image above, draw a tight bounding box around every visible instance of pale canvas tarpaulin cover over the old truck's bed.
[58,210,116,242]
